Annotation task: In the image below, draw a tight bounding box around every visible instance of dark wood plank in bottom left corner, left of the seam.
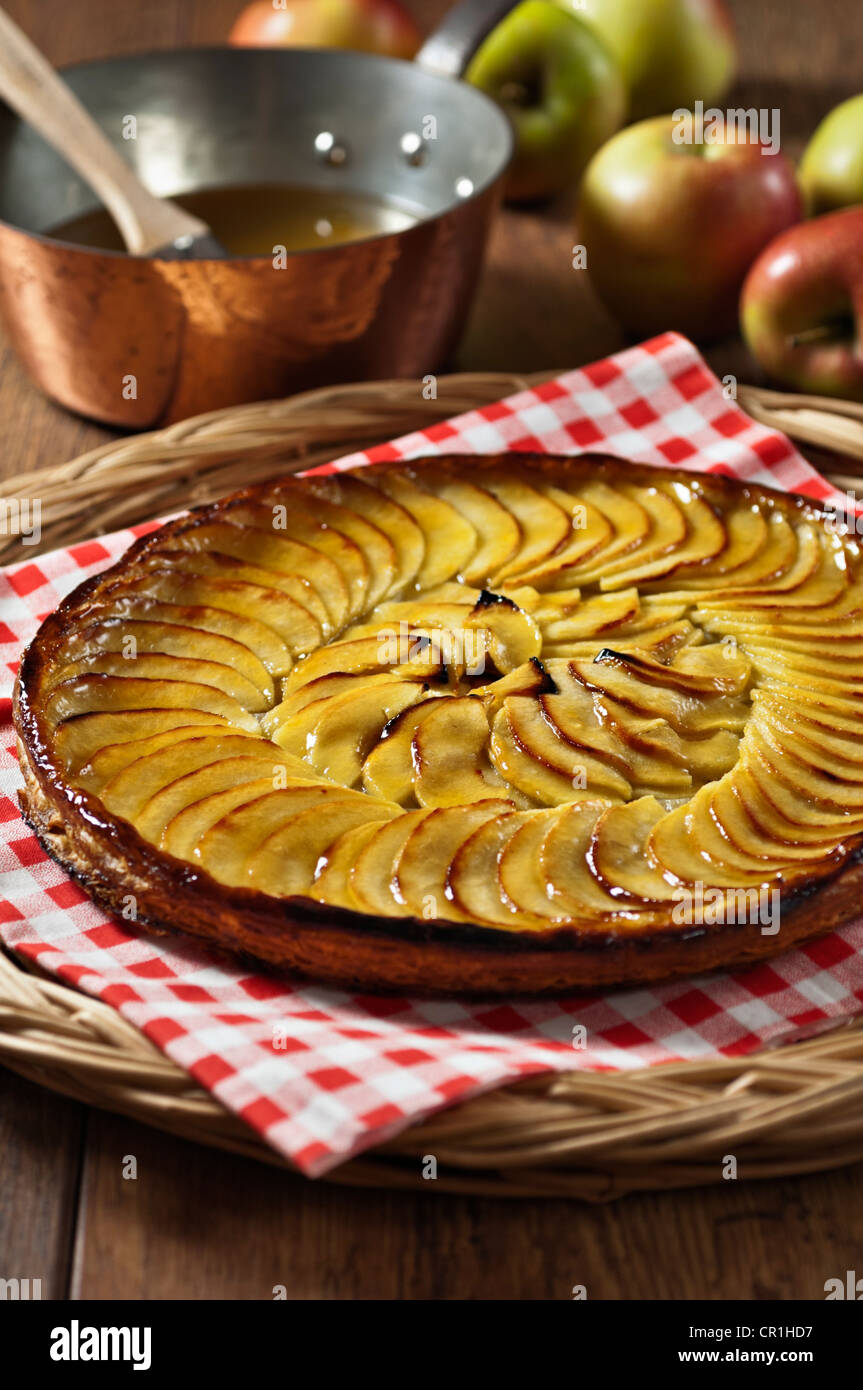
[0,1069,86,1298]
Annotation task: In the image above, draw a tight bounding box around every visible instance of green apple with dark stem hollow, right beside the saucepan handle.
[466,0,627,202]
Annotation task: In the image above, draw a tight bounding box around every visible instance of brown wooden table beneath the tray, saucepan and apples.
[0,0,863,1300]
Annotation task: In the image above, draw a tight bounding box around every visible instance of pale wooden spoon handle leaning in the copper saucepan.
[0,10,208,256]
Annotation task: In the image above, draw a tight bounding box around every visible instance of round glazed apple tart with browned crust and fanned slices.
[15,455,863,994]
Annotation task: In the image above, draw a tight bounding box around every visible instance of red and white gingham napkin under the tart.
[0,334,863,1175]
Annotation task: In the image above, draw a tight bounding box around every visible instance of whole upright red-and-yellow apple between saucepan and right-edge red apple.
[578,115,802,339]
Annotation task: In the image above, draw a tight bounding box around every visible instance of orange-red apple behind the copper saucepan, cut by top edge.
[228,0,421,58]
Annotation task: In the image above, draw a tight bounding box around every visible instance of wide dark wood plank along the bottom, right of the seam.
[72,1115,860,1300]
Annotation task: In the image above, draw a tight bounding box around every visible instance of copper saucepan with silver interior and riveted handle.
[0,0,513,430]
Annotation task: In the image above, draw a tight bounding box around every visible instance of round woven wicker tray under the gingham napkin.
[0,373,863,1201]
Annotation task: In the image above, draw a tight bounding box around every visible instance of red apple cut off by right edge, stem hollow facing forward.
[741,207,863,400]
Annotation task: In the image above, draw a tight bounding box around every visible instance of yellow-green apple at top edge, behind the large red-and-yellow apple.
[560,0,737,121]
